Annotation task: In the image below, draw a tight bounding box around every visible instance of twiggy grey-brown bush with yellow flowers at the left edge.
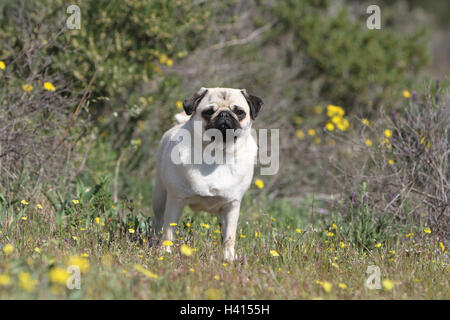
[0,2,80,194]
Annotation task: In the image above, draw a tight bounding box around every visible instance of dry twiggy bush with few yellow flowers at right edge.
[341,81,450,239]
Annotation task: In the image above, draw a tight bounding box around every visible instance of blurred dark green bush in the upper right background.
[269,0,428,113]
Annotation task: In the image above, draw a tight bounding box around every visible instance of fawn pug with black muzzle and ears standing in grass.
[152,88,263,261]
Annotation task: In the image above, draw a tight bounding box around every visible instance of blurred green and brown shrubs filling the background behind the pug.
[0,0,450,238]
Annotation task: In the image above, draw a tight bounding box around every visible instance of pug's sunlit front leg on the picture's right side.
[222,201,241,261]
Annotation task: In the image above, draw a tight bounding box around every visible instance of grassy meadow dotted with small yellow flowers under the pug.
[0,182,450,299]
